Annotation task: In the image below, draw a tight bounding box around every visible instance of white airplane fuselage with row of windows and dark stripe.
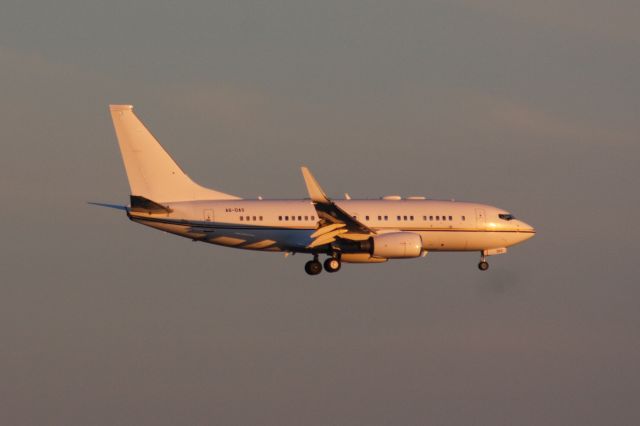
[129,200,535,253]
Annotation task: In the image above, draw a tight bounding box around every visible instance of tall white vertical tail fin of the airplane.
[109,105,239,202]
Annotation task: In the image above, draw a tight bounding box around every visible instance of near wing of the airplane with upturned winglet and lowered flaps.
[301,166,375,248]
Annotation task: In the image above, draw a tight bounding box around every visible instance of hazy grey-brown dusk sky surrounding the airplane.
[0,0,640,425]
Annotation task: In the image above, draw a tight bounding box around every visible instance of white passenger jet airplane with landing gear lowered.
[90,105,536,275]
